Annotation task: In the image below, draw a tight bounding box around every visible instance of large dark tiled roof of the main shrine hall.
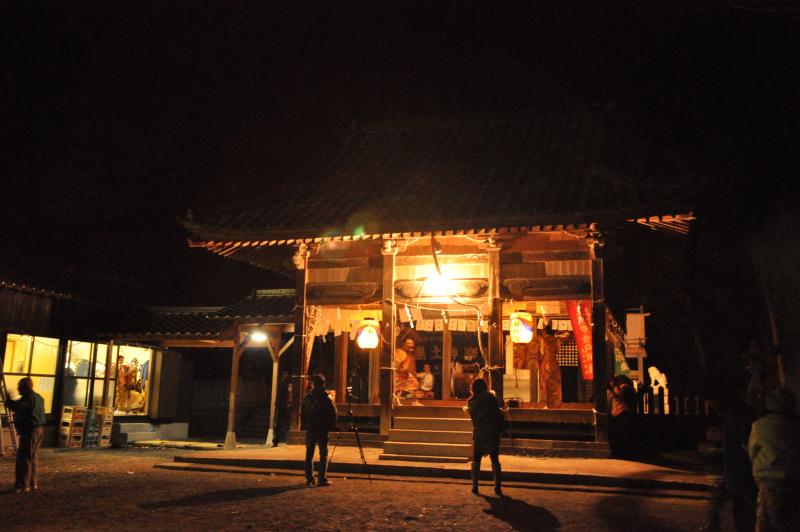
[185,107,696,245]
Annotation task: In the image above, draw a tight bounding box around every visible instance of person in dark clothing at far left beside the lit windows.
[7,377,47,493]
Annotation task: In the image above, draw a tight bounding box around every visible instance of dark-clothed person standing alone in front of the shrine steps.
[466,379,505,497]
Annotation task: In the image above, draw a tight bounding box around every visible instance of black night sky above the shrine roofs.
[0,0,800,304]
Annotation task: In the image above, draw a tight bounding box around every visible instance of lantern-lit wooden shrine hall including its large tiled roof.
[185,109,692,441]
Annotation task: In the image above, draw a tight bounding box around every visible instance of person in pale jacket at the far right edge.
[747,389,800,532]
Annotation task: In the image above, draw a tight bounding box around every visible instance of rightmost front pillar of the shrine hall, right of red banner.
[590,240,613,442]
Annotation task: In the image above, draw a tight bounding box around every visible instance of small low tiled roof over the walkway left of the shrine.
[111,289,295,339]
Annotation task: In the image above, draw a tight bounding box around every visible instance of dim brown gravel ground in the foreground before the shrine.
[0,449,720,531]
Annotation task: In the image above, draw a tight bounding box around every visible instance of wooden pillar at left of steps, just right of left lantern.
[379,240,397,435]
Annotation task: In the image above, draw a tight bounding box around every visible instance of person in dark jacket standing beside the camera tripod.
[301,375,336,486]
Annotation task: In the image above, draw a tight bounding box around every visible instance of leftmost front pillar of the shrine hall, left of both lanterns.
[289,244,313,430]
